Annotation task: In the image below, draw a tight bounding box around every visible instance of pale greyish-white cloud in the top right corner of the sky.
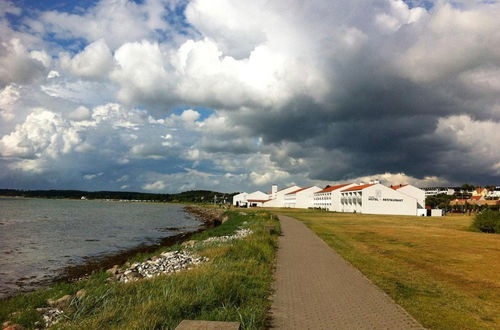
[395,2,500,82]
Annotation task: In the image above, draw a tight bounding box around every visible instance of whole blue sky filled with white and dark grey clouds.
[0,0,500,193]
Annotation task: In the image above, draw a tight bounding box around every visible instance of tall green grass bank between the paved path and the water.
[0,212,279,329]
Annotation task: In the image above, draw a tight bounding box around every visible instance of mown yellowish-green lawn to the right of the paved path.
[276,209,500,329]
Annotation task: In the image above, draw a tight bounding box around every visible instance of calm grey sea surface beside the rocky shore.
[0,198,201,298]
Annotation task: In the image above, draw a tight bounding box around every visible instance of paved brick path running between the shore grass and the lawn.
[271,216,422,330]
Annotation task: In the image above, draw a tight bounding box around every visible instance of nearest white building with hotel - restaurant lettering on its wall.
[340,183,418,215]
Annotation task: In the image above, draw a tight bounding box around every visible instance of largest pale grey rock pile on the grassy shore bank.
[116,251,208,283]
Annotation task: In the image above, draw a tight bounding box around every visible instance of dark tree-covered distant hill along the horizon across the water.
[0,189,237,203]
